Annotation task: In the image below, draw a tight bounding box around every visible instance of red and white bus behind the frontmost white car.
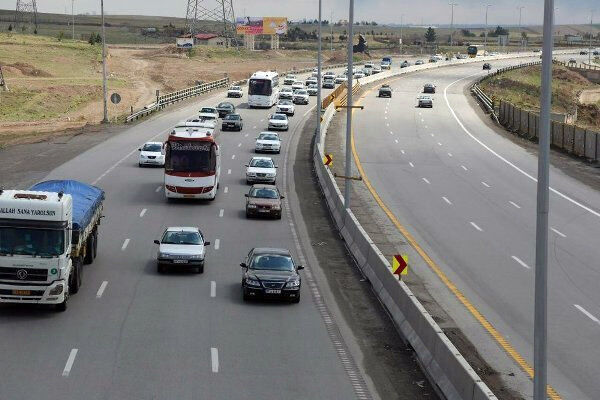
[165,127,221,200]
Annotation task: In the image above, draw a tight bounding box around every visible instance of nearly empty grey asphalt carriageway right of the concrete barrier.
[354,57,600,399]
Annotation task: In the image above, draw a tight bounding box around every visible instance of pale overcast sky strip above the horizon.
[11,0,600,25]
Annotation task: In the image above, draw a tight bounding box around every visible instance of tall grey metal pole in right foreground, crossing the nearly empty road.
[533,0,554,400]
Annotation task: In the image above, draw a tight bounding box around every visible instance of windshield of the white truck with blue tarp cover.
[0,227,65,257]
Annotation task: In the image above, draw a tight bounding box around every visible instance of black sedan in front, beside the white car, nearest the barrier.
[240,247,304,303]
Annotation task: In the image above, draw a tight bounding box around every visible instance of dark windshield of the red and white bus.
[165,140,217,173]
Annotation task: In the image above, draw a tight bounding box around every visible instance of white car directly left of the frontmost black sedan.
[154,226,210,274]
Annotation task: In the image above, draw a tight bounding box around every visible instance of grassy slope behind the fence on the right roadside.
[480,65,600,130]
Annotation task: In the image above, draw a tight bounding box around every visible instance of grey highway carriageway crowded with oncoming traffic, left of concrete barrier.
[0,69,371,400]
